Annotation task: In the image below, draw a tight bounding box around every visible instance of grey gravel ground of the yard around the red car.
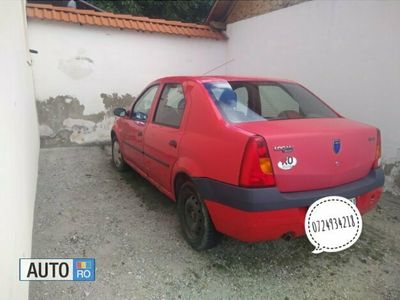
[30,147,400,299]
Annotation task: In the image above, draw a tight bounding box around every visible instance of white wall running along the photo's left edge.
[0,0,39,299]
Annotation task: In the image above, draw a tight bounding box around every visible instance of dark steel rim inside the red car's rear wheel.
[184,194,204,239]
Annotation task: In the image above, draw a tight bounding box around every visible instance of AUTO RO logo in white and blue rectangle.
[19,258,96,281]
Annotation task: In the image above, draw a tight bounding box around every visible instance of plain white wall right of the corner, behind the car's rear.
[226,0,400,161]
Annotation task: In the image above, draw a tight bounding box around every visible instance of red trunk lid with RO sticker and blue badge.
[235,118,377,192]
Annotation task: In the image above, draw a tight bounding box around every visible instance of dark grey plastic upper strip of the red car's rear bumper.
[193,169,385,212]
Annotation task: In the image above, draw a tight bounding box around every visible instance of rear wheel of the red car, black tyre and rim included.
[178,181,220,251]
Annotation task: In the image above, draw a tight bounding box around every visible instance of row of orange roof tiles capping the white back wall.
[26,3,226,40]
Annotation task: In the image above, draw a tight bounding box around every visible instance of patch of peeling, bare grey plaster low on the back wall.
[36,93,135,147]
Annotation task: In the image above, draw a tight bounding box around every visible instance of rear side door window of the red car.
[154,83,186,128]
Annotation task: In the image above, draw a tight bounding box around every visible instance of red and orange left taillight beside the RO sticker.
[239,136,275,187]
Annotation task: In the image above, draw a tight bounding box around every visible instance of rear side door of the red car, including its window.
[144,83,186,193]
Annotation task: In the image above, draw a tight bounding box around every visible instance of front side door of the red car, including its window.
[122,85,158,172]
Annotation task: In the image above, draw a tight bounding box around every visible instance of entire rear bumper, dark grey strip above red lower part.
[194,169,384,242]
